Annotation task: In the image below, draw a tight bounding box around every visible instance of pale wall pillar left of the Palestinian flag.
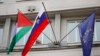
[0,18,11,49]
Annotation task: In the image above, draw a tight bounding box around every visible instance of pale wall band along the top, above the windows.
[0,0,100,15]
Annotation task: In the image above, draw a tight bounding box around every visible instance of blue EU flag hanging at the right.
[78,13,95,56]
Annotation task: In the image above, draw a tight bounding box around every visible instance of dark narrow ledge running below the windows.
[0,44,100,53]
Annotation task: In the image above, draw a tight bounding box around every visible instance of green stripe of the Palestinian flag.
[7,27,31,54]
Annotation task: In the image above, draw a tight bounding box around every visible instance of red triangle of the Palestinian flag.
[17,11,33,27]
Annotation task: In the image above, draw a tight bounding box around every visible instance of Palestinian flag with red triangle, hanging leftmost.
[7,11,32,54]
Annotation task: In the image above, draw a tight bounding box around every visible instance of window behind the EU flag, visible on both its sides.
[67,21,100,44]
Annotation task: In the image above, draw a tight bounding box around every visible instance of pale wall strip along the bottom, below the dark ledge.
[0,47,100,56]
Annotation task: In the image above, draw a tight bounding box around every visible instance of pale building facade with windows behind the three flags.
[0,0,100,56]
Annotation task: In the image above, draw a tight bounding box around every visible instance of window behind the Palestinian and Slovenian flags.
[11,23,52,46]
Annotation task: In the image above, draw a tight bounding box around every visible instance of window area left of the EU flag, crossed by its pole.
[67,21,80,43]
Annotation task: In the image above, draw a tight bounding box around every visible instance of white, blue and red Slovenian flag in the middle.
[22,8,49,56]
